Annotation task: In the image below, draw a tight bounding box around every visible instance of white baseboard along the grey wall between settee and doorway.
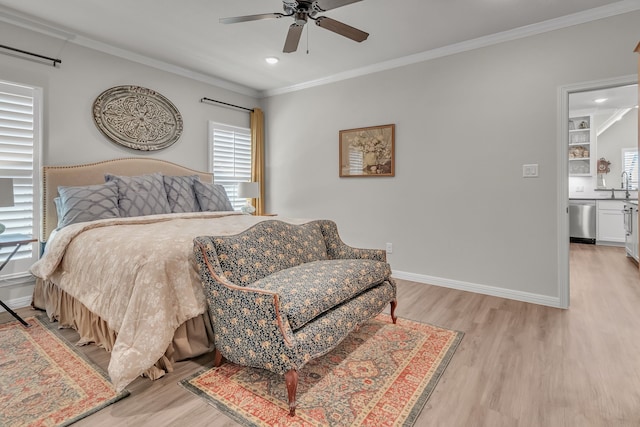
[393,270,562,308]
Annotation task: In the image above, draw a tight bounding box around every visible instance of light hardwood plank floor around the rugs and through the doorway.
[5,244,640,427]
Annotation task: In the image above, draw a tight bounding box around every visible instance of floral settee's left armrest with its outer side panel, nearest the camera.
[194,237,304,374]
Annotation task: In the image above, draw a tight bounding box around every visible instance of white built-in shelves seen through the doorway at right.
[569,116,596,176]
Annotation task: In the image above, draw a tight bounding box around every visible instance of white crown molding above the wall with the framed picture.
[260,0,640,97]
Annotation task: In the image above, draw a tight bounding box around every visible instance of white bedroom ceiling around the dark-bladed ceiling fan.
[0,0,640,95]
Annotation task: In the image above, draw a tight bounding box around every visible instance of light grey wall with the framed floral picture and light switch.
[265,12,640,305]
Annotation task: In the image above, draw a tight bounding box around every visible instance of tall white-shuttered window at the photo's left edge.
[0,82,42,279]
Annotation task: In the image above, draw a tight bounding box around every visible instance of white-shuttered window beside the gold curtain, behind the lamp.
[209,122,251,210]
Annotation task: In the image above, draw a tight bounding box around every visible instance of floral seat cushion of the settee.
[251,259,391,331]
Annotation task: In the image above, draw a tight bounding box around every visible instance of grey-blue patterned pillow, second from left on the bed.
[104,173,171,217]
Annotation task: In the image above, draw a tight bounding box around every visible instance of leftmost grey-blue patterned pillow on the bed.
[54,182,120,229]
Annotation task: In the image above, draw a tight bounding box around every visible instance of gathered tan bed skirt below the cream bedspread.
[32,278,213,380]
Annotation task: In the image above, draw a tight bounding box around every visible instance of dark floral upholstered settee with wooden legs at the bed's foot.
[194,220,396,415]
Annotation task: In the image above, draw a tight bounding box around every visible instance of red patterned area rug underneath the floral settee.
[180,315,463,427]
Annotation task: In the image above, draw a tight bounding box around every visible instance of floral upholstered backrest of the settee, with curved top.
[213,221,327,286]
